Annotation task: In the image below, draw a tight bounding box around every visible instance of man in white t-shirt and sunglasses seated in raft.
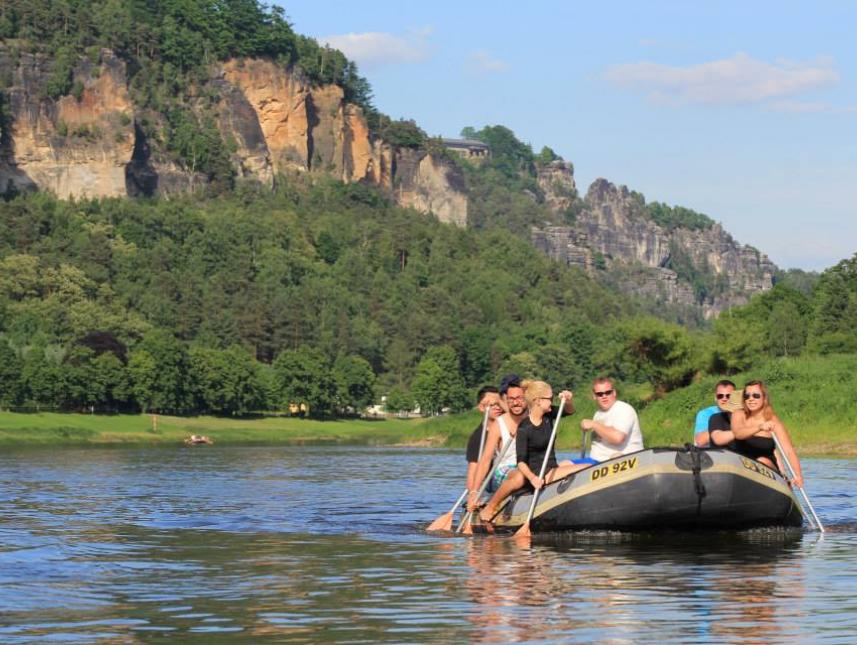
[580,376,643,461]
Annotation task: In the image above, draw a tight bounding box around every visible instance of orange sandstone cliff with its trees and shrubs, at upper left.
[0,2,467,226]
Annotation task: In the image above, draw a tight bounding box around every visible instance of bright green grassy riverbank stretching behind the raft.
[5,356,857,456]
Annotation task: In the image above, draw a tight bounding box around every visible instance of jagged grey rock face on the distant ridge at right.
[532,179,776,318]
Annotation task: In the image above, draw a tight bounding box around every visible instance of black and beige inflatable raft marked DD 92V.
[473,447,803,533]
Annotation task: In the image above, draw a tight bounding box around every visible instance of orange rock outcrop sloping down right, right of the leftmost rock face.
[216,60,467,226]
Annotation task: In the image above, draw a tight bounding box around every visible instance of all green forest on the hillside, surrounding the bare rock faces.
[0,0,857,417]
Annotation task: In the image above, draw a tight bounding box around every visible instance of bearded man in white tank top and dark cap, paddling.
[467,374,527,511]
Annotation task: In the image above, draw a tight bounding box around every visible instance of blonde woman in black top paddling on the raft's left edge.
[479,381,588,522]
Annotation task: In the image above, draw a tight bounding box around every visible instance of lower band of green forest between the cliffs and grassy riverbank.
[0,177,857,416]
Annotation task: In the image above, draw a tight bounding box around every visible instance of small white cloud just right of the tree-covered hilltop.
[319,27,432,67]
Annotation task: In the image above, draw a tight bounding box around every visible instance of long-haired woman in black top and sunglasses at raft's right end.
[711,381,803,486]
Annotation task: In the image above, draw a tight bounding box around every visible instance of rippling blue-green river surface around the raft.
[0,445,857,644]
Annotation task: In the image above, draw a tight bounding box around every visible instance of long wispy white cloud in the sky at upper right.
[605,53,839,105]
